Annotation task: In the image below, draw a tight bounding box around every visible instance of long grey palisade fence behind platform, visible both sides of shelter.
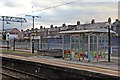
[0,37,120,56]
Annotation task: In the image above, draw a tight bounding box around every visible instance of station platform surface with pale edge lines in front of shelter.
[0,54,120,76]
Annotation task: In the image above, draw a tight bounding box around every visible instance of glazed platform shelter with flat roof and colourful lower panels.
[60,29,115,61]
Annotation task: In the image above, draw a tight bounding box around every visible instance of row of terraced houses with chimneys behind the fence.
[0,19,120,40]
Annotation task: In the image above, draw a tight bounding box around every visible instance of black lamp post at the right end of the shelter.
[108,17,111,62]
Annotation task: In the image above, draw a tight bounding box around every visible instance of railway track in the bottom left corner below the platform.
[0,66,46,80]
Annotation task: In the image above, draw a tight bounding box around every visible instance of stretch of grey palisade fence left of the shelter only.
[0,39,62,50]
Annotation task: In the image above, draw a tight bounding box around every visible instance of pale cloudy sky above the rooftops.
[0,0,119,30]
